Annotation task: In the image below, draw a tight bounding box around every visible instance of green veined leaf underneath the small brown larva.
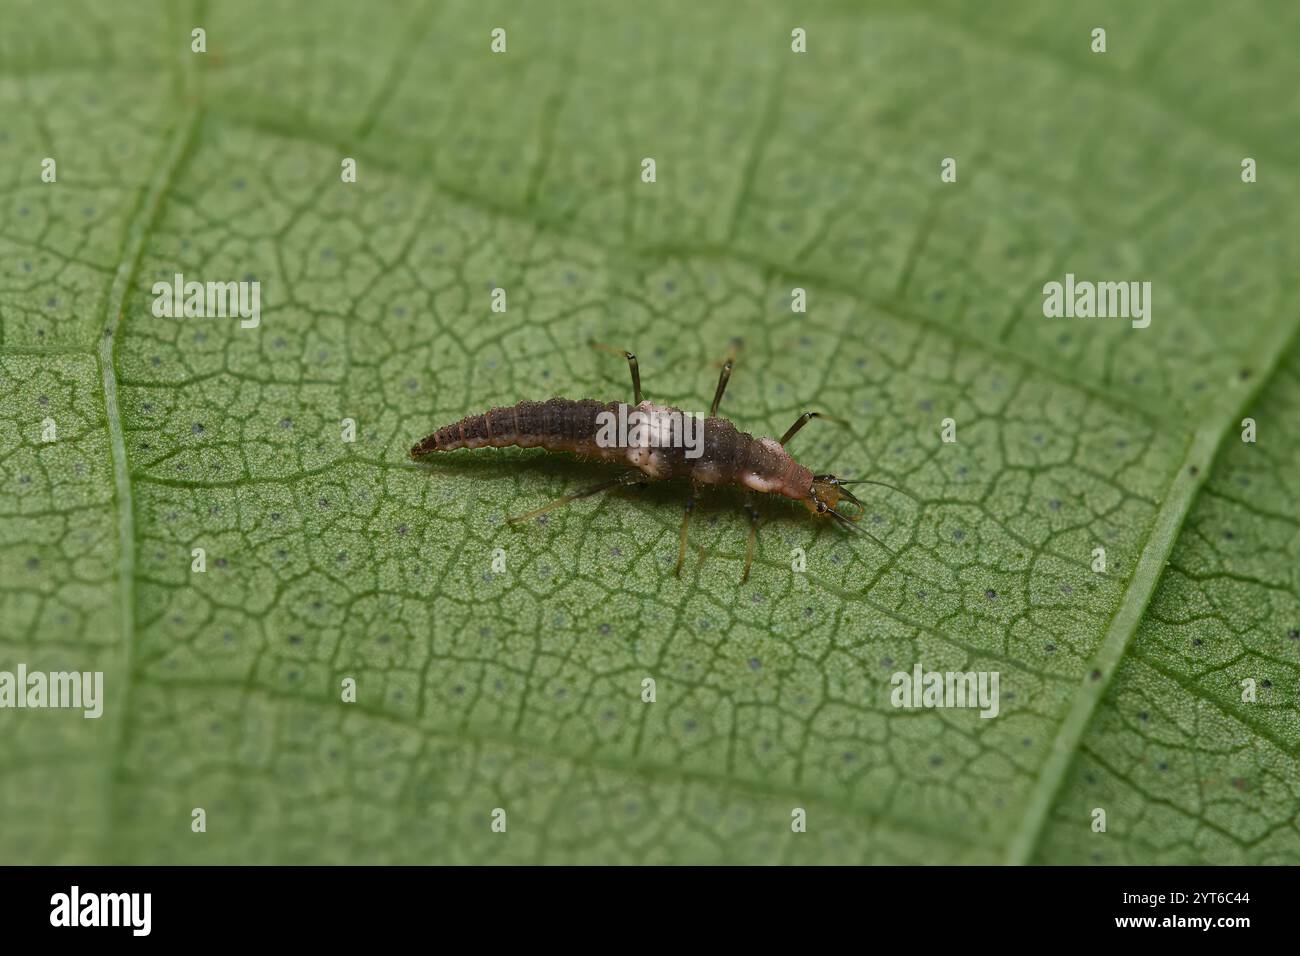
[0,0,1300,864]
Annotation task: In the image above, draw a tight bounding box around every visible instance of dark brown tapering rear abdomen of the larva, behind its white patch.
[411,398,624,458]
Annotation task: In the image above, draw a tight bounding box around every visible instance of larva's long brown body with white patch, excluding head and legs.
[411,398,813,501]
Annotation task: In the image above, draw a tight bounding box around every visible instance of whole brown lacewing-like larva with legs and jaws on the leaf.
[411,343,910,583]
